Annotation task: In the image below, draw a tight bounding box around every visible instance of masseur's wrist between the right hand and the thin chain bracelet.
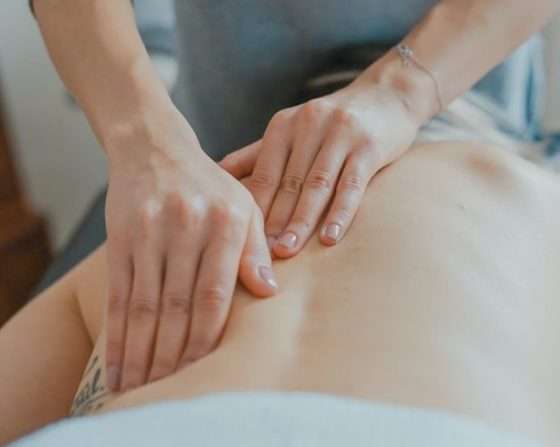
[357,49,441,126]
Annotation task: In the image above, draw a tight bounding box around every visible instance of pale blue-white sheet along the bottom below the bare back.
[13,393,538,447]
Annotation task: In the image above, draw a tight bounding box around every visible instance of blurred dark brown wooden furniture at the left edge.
[0,86,51,326]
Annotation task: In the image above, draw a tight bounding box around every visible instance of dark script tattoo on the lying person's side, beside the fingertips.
[70,355,111,417]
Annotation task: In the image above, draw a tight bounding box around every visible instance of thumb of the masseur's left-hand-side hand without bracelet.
[239,205,278,298]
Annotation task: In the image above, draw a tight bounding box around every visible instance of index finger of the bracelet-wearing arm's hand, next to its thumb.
[248,109,293,220]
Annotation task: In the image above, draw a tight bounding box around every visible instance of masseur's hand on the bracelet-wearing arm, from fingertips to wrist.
[220,78,420,258]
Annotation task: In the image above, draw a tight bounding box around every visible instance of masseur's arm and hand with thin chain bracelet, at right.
[221,0,560,257]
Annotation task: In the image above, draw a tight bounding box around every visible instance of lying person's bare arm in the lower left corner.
[0,273,92,445]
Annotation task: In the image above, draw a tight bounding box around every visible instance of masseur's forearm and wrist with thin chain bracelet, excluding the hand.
[358,0,559,121]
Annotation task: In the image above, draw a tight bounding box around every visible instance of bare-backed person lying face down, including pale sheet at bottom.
[0,102,560,446]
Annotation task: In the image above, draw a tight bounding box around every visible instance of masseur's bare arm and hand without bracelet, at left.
[34,0,276,396]
